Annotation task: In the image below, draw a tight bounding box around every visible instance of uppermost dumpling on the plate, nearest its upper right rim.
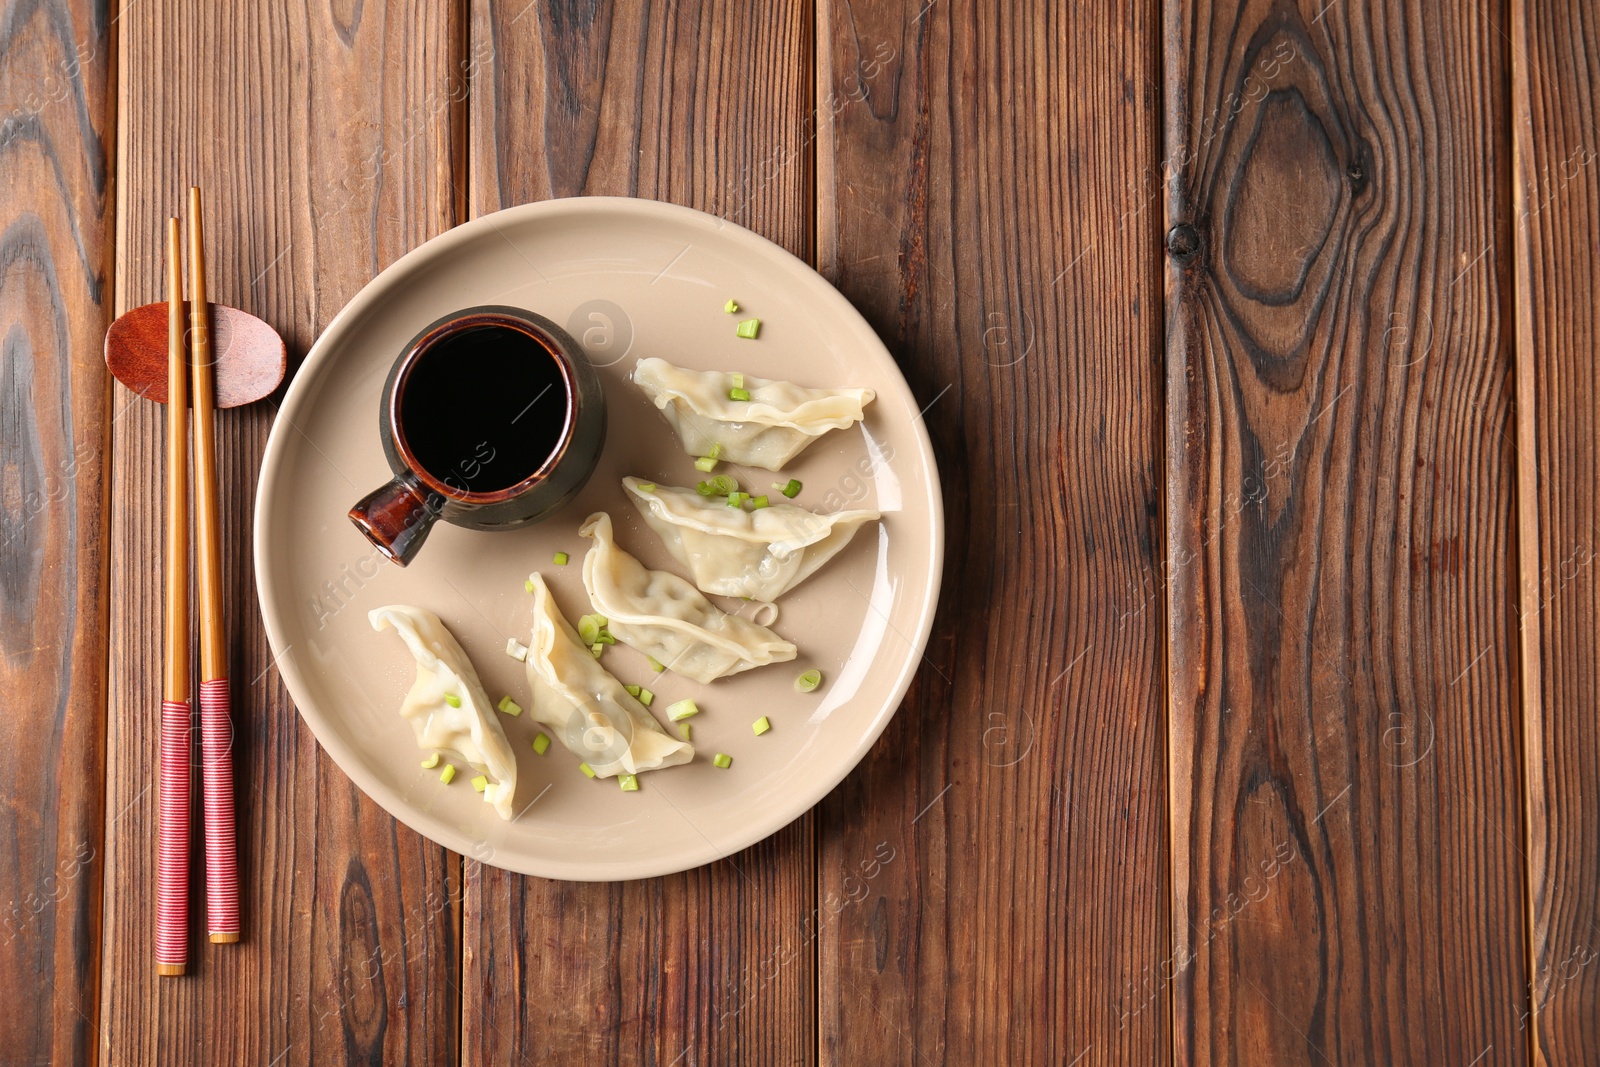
[634,358,877,470]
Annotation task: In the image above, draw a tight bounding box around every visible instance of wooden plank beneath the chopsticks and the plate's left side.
[101,0,464,1064]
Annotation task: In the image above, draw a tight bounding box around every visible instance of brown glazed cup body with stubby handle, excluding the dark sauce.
[350,304,606,566]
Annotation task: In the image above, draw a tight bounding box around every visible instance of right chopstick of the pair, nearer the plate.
[189,189,240,944]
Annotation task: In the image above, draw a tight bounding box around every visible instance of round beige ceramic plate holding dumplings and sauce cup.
[256,198,944,880]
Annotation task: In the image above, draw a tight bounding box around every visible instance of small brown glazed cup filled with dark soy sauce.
[350,306,606,566]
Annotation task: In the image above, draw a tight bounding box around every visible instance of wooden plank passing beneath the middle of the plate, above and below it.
[462,0,814,1064]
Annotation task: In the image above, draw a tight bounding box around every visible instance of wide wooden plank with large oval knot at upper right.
[1166,0,1526,1064]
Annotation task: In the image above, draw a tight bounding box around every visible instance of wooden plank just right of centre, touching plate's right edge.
[819,0,1168,1065]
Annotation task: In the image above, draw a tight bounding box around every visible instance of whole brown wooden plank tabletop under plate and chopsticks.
[0,0,1600,1067]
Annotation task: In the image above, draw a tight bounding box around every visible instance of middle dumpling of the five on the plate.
[578,512,795,681]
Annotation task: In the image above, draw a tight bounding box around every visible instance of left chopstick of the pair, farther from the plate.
[155,219,190,974]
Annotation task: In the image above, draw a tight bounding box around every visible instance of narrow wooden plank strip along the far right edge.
[1510,0,1600,1064]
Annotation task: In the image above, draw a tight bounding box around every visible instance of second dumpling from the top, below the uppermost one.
[622,478,878,600]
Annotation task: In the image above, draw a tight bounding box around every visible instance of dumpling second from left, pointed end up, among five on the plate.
[526,574,694,777]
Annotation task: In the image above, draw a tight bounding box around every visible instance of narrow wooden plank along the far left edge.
[0,0,114,1064]
